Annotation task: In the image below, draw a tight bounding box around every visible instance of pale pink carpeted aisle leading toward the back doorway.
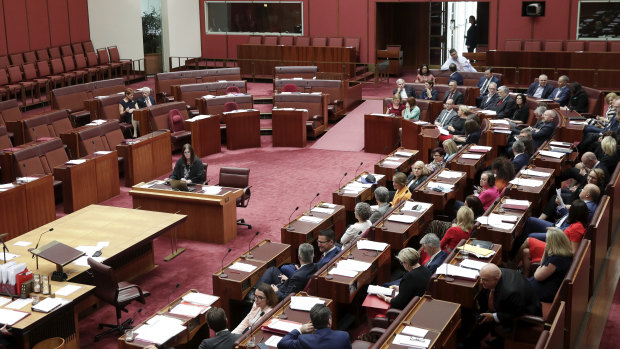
[310,100,384,151]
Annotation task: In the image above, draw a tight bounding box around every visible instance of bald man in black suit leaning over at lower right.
[465,263,542,348]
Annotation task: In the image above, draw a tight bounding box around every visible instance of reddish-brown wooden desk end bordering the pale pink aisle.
[364,114,403,154]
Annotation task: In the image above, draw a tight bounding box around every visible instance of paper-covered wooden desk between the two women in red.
[476,196,532,258]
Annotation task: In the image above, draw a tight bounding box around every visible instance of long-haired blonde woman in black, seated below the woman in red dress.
[523,228,575,303]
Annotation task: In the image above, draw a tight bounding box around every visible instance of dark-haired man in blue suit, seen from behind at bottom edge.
[278,304,351,349]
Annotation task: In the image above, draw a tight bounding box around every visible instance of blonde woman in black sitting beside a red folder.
[378,247,432,309]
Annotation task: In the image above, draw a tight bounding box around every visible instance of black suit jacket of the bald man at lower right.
[479,268,542,328]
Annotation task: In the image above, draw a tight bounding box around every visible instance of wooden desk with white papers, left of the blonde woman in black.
[317,239,390,304]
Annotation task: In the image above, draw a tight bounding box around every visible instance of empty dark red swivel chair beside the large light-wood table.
[88,258,150,341]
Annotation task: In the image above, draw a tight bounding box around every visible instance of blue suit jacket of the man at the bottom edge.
[278,327,351,349]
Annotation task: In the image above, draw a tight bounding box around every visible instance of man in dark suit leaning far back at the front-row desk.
[250,243,317,300]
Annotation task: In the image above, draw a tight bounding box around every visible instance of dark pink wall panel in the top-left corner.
[4,0,30,53]
